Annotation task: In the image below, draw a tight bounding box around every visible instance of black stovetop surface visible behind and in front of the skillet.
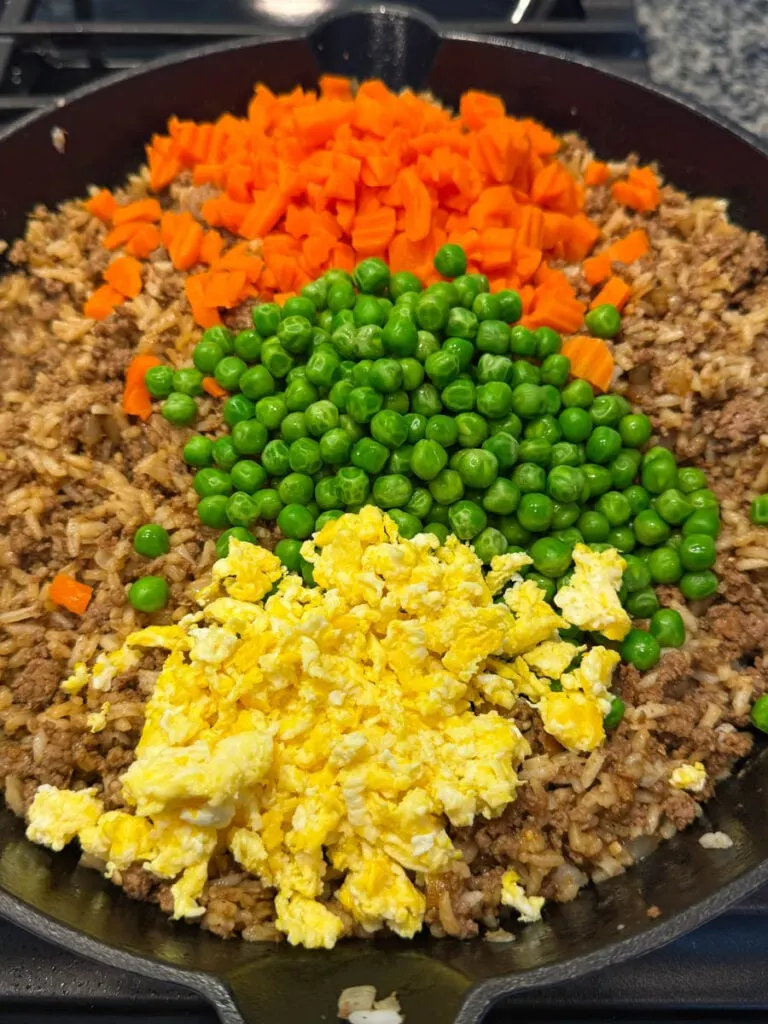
[0,0,768,1024]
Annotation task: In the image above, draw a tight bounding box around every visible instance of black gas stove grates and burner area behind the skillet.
[0,0,646,123]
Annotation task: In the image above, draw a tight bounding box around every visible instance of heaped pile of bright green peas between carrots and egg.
[140,245,720,684]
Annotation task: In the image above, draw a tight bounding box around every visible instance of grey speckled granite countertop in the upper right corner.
[636,0,768,137]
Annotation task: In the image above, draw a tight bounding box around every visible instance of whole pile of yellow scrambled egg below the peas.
[28,507,626,948]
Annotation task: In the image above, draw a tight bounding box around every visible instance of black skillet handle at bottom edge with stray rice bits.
[221,942,475,1024]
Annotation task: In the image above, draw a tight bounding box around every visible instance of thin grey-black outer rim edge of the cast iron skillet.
[0,4,768,1024]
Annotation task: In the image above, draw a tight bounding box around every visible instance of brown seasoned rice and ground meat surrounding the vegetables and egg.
[0,136,768,939]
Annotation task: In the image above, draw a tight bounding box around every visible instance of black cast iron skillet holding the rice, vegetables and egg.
[0,8,768,1024]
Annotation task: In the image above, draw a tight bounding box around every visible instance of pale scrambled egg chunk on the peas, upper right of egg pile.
[555,544,632,640]
